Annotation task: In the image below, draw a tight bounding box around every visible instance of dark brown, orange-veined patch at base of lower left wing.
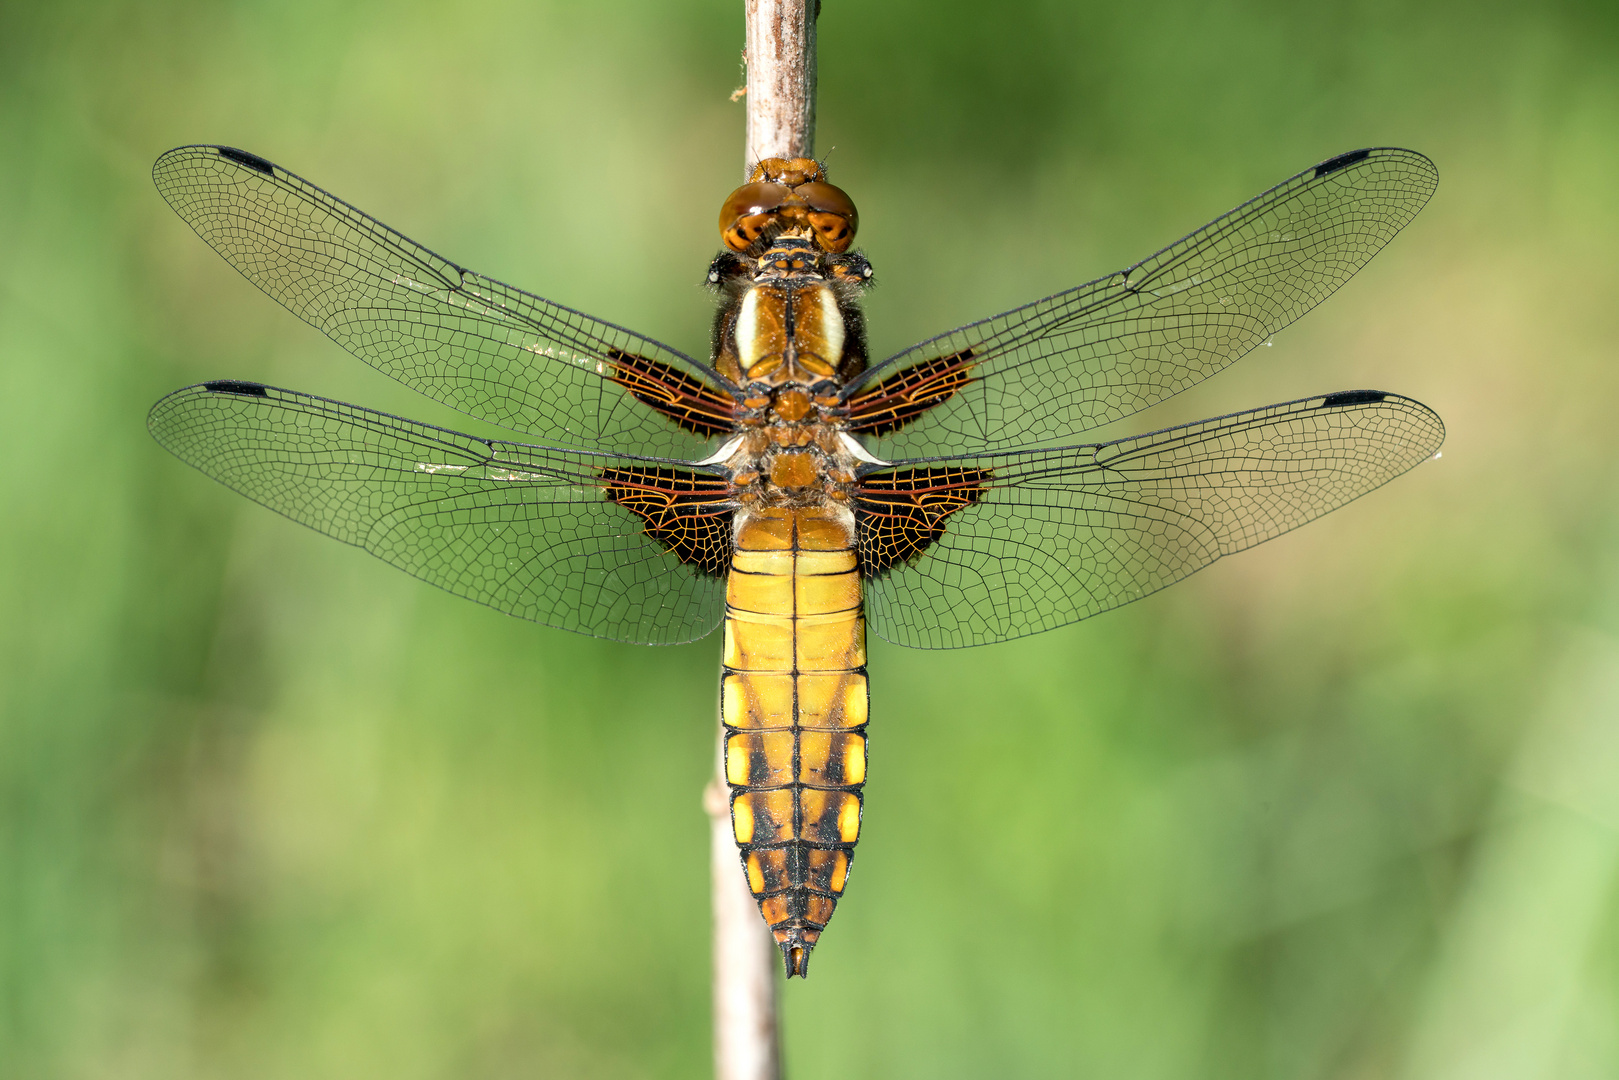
[601,468,733,578]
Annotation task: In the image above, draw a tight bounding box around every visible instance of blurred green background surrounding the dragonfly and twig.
[0,0,1619,1080]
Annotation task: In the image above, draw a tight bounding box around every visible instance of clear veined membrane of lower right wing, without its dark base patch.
[866,390,1444,649]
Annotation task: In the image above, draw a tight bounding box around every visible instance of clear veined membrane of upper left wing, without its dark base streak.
[152,146,727,458]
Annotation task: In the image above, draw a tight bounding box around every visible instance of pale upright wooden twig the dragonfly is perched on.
[703,0,821,1080]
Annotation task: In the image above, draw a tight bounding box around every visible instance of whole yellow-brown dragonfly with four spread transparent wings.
[147,146,1444,978]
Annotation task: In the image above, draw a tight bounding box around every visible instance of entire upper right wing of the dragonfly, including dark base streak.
[845,149,1438,458]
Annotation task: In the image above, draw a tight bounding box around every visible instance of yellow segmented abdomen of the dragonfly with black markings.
[720,508,866,976]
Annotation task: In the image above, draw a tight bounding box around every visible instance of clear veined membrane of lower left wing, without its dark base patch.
[147,382,729,644]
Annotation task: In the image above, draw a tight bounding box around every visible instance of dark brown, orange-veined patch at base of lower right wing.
[855,468,991,578]
